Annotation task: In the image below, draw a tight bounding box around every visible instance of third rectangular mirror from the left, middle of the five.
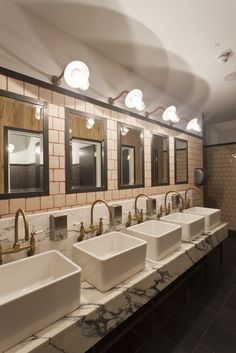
[118,123,144,189]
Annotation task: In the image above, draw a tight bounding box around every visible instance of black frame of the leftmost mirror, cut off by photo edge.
[0,89,49,200]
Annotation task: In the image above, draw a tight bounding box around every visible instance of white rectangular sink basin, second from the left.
[73,232,147,292]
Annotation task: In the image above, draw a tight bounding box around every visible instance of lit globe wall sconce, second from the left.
[108,89,145,112]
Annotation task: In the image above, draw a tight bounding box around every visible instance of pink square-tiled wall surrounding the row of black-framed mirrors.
[0,75,203,218]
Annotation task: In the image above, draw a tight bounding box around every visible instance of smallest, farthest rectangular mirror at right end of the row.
[175,138,188,184]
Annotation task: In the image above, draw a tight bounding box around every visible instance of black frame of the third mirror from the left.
[117,122,145,190]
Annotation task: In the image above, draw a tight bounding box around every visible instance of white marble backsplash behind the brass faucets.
[0,191,195,263]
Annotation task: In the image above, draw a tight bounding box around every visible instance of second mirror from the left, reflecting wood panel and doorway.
[65,109,107,193]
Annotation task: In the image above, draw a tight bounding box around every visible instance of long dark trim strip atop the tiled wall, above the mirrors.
[0,66,202,140]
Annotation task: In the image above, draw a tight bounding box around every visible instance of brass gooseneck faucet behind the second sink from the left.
[77,200,112,241]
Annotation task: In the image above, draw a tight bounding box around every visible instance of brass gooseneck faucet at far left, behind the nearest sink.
[0,208,35,265]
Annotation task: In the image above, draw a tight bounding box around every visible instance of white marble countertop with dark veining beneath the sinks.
[7,223,228,353]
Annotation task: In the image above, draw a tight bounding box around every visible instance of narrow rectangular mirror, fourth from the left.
[151,134,169,186]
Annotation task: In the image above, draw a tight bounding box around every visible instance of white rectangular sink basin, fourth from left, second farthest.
[161,212,205,242]
